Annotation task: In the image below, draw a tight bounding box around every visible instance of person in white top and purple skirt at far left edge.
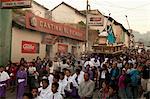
[0,66,10,99]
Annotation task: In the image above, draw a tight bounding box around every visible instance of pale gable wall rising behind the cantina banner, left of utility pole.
[52,4,86,24]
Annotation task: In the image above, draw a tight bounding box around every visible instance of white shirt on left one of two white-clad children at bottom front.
[39,86,51,99]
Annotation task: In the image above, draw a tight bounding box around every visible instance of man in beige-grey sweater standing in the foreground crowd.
[78,72,95,99]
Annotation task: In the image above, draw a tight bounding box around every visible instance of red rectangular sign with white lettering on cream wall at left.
[22,41,39,53]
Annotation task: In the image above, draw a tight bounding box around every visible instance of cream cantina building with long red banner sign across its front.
[11,2,85,62]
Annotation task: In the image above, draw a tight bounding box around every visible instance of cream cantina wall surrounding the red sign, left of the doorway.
[11,27,46,62]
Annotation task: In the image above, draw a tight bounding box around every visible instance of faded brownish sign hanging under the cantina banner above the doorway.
[41,34,58,45]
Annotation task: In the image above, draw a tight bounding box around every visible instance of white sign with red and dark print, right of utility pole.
[88,15,104,26]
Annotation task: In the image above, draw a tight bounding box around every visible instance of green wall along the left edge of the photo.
[0,9,12,65]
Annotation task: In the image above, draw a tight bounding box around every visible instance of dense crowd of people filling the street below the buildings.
[0,50,150,99]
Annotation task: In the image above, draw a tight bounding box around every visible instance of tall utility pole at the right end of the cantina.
[85,0,89,52]
